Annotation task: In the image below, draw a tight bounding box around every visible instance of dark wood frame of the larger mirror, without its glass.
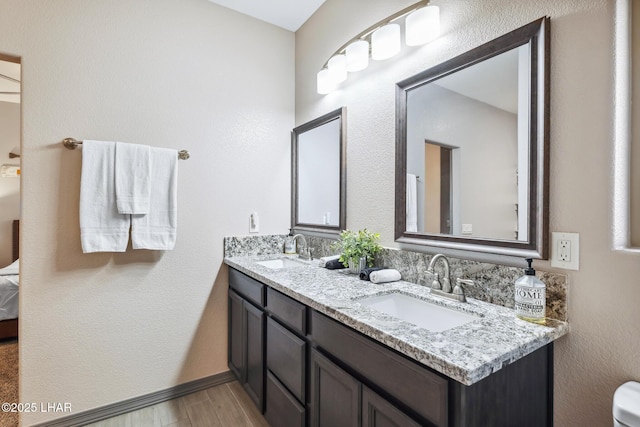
[395,17,550,259]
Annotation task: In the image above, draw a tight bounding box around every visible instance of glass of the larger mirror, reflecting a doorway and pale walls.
[407,45,530,241]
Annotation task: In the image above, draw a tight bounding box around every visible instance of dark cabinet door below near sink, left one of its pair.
[310,350,360,427]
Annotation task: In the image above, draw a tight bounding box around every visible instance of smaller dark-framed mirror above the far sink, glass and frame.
[291,107,347,233]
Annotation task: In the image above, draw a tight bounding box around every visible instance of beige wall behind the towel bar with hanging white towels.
[0,0,294,425]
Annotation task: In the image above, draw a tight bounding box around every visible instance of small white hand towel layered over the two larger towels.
[115,142,151,214]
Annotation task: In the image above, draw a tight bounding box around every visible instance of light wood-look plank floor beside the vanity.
[83,381,268,427]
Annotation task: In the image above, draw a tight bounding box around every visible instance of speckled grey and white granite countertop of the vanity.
[224,254,569,385]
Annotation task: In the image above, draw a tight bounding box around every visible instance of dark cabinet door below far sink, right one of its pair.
[243,301,265,412]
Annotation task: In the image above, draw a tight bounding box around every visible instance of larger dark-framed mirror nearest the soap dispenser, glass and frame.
[395,18,549,259]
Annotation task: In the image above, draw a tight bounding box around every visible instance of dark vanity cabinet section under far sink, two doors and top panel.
[228,269,266,411]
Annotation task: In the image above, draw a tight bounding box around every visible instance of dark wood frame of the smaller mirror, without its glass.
[291,107,347,234]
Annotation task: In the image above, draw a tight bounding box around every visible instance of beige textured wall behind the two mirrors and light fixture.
[296,0,640,427]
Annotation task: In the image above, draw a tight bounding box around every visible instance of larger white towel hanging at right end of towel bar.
[131,148,178,250]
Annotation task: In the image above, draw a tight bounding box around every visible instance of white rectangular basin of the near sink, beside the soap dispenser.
[357,293,480,332]
